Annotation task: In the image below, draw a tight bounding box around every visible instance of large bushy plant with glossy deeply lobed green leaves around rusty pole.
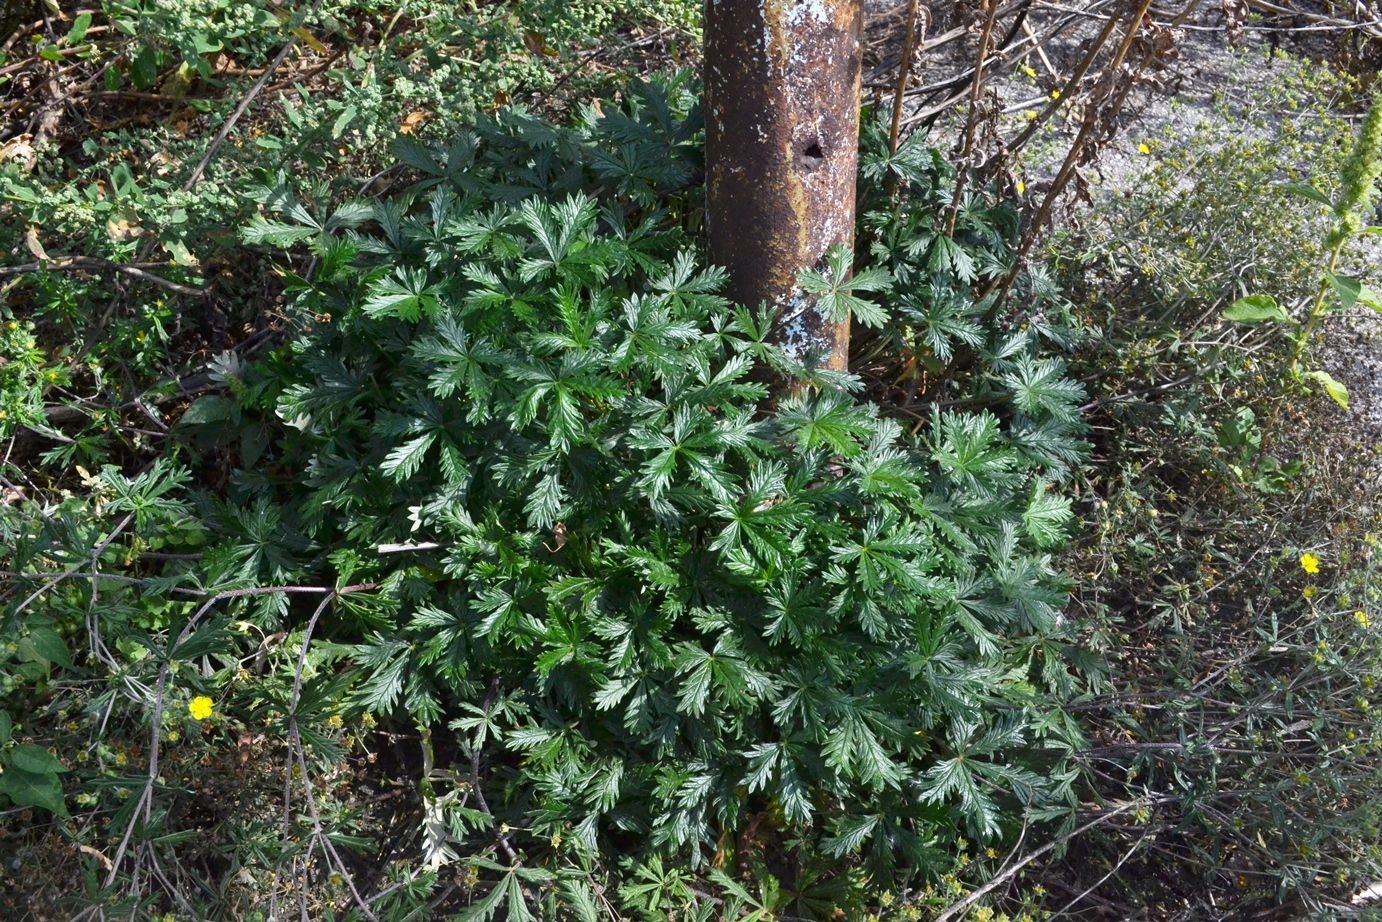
[145,82,1089,918]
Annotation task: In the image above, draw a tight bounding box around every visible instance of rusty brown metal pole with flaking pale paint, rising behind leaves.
[705,0,862,370]
